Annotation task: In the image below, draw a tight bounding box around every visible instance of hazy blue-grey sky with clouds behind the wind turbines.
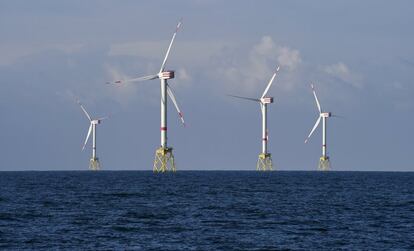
[0,0,414,171]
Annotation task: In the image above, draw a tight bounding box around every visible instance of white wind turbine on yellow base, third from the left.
[229,67,279,171]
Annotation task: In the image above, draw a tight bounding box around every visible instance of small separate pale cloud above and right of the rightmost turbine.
[322,62,363,88]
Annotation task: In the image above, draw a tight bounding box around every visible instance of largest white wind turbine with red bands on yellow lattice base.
[107,20,185,172]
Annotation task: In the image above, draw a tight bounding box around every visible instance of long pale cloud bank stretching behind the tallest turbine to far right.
[108,36,362,101]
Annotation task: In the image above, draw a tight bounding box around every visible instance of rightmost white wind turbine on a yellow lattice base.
[305,84,337,171]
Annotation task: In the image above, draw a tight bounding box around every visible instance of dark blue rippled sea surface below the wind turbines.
[0,171,414,250]
